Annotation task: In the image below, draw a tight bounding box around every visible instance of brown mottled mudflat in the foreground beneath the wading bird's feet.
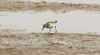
[0,33,100,55]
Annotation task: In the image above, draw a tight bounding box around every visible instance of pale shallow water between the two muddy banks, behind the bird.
[0,10,100,33]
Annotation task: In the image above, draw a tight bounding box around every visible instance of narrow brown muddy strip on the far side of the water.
[0,1,100,12]
